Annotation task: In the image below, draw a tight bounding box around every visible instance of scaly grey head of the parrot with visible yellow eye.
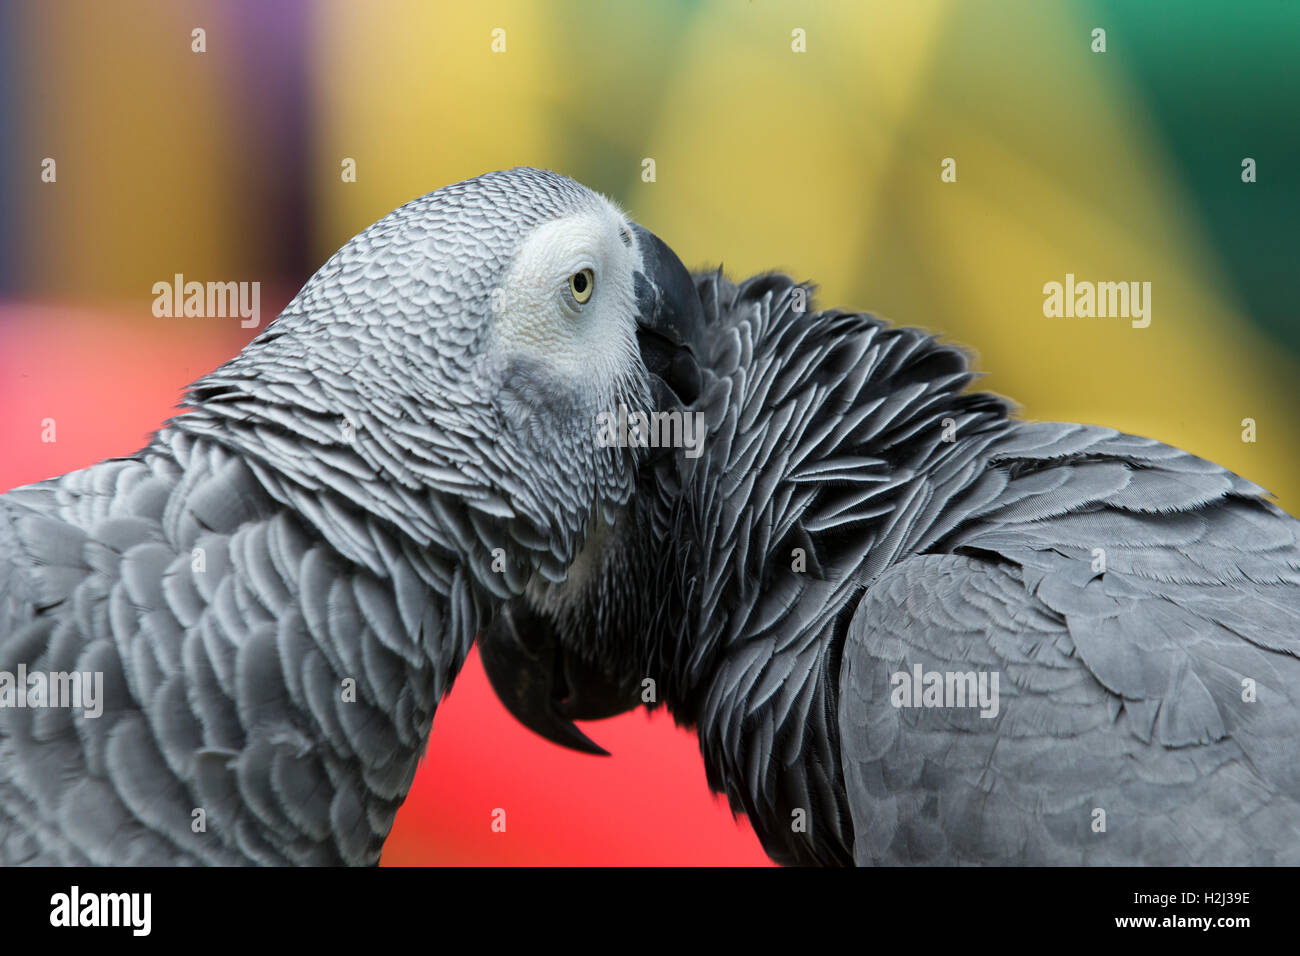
[185,168,701,580]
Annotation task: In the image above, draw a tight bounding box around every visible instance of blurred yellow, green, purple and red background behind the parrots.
[0,0,1300,865]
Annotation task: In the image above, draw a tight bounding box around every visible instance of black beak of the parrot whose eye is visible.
[632,224,705,408]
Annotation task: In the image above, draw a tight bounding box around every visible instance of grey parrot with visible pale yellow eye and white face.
[0,169,699,864]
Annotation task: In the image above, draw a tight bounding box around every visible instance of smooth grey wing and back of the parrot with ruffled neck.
[840,425,1300,865]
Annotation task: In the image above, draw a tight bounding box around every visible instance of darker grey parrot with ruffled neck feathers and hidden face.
[482,271,1300,865]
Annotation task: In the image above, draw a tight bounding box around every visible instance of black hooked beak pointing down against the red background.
[478,598,641,757]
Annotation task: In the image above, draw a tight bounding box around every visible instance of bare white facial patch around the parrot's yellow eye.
[493,202,640,390]
